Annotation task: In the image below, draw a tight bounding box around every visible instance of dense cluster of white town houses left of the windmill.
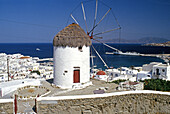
[0,53,53,82]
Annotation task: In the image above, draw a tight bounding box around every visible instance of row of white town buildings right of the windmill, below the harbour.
[93,62,170,82]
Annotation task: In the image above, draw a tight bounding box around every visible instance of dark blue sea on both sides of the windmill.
[0,43,170,70]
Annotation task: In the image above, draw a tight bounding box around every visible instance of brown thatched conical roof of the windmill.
[53,23,91,47]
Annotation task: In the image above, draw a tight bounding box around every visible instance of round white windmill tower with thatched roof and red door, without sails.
[53,23,91,88]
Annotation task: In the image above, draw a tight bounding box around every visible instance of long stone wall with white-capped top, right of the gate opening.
[37,91,170,114]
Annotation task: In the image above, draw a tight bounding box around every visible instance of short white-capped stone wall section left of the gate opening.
[0,99,14,114]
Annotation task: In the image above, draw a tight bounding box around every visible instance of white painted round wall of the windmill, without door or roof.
[53,46,90,88]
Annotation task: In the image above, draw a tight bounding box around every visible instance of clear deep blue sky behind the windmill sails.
[0,0,170,43]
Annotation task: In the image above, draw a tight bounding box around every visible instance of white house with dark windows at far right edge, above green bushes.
[152,64,170,80]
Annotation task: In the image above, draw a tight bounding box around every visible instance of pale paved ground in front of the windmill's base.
[42,79,118,97]
